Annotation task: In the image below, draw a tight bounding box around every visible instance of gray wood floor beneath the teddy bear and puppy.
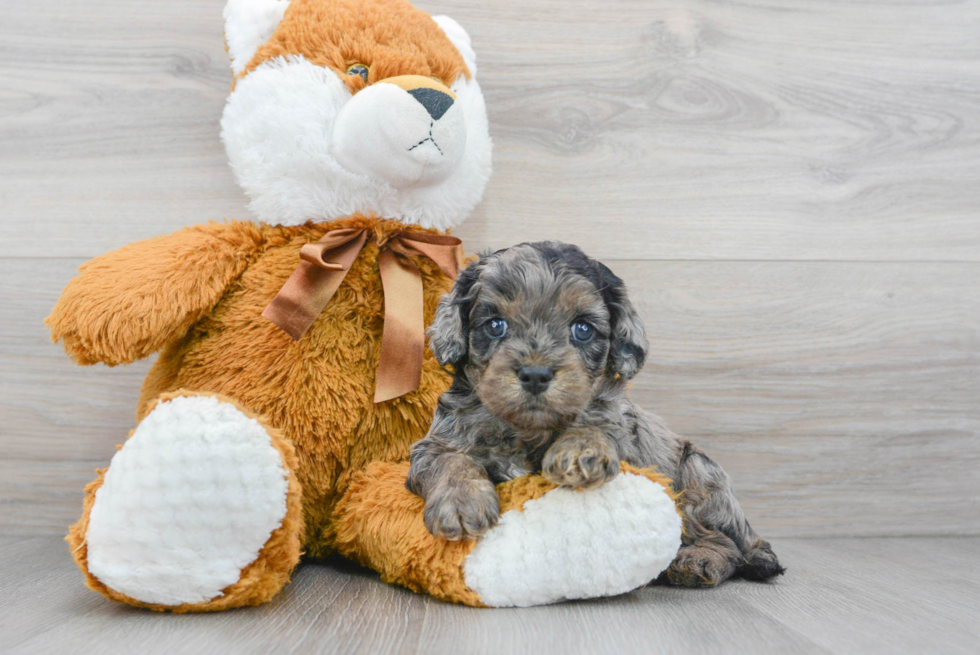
[0,538,980,655]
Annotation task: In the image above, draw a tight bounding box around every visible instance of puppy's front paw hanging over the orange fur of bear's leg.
[423,480,500,541]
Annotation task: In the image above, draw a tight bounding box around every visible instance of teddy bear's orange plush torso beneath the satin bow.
[131,217,452,556]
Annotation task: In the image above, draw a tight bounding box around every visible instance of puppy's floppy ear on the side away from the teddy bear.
[596,262,649,380]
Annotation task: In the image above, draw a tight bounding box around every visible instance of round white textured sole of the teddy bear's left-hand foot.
[86,396,287,605]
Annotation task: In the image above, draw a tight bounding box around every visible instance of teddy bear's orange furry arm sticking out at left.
[45,222,262,366]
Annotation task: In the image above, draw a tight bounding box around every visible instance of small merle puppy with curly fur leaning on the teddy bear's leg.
[407,241,783,587]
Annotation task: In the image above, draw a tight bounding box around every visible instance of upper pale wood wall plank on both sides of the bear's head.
[0,0,980,261]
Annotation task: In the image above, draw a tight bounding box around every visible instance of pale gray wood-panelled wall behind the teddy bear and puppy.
[0,0,980,544]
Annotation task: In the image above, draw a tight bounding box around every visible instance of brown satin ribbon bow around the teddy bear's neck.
[262,228,463,403]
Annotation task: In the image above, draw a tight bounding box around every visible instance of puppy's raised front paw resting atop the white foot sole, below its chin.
[541,430,619,489]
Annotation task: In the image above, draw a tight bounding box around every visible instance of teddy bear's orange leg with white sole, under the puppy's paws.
[333,462,681,607]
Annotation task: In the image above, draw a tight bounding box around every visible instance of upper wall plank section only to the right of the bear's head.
[453,0,980,261]
